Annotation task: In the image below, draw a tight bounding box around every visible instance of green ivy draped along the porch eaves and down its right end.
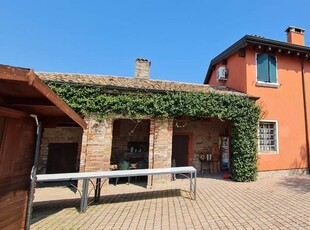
[48,82,260,181]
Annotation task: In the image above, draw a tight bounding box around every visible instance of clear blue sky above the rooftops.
[0,0,310,83]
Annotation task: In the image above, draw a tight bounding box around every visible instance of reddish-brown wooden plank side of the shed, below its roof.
[0,117,36,229]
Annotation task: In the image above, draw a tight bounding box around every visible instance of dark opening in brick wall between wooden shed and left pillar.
[46,143,78,173]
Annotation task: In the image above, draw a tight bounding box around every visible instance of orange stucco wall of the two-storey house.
[210,49,310,171]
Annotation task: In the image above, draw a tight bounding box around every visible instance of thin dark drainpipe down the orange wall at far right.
[301,58,310,174]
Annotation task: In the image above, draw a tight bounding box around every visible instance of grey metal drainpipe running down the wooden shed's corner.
[25,114,42,230]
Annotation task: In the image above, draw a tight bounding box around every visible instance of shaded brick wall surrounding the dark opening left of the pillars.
[38,127,83,174]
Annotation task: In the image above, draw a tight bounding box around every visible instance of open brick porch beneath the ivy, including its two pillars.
[39,116,231,187]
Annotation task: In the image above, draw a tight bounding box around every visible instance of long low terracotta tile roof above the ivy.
[36,72,246,96]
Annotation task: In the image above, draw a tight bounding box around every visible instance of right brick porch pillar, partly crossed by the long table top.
[148,119,173,187]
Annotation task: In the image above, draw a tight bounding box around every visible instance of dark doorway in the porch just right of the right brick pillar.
[172,135,189,167]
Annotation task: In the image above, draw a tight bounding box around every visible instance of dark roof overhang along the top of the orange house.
[204,35,310,84]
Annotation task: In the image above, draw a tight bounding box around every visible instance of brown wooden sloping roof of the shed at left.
[0,65,87,129]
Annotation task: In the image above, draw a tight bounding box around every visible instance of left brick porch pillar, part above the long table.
[80,115,113,172]
